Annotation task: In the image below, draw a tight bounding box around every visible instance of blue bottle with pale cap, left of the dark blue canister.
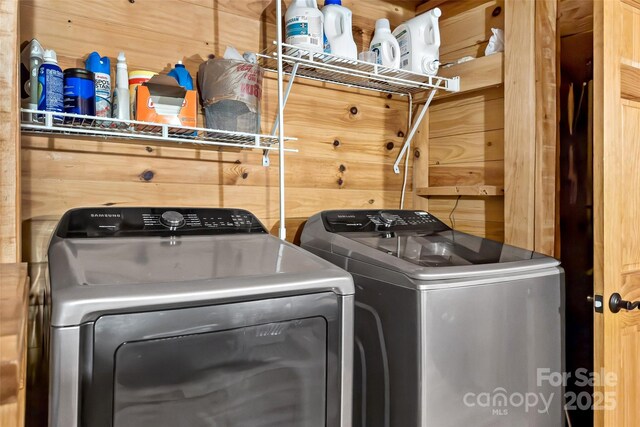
[38,49,64,123]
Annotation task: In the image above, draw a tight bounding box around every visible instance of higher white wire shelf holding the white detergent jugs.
[258,42,460,95]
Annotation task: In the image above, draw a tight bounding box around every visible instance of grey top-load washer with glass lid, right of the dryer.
[302,210,564,427]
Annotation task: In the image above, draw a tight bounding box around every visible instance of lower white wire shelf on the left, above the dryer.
[20,108,298,152]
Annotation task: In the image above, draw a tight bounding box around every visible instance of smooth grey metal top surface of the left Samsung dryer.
[49,209,354,326]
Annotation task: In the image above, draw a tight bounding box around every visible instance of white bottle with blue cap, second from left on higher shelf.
[322,0,358,60]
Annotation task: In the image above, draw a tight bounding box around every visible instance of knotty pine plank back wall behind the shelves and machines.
[20,0,415,261]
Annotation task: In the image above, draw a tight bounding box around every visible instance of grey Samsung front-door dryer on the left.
[49,208,354,427]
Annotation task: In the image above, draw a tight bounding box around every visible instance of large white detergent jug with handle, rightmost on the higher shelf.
[393,7,442,76]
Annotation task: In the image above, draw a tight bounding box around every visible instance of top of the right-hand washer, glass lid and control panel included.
[321,210,559,280]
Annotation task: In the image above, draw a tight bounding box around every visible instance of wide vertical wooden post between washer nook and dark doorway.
[504,0,559,256]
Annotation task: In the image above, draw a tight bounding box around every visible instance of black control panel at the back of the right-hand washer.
[322,210,449,233]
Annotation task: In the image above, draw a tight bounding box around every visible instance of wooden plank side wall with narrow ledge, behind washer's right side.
[414,0,505,240]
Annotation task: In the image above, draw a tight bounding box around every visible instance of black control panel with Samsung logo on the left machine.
[56,208,267,238]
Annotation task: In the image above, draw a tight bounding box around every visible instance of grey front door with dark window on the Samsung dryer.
[82,293,339,427]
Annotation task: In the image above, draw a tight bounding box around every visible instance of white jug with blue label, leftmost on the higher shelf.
[284,0,324,53]
